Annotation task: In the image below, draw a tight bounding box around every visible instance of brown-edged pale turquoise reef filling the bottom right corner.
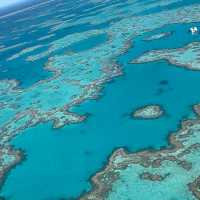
[80,105,200,200]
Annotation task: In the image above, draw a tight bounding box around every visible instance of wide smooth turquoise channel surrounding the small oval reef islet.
[1,18,200,200]
